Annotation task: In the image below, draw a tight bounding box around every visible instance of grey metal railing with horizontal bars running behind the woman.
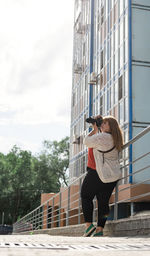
[13,126,150,233]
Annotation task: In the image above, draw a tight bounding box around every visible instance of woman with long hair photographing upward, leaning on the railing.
[81,116,123,236]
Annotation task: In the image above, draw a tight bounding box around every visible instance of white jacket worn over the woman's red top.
[83,132,121,183]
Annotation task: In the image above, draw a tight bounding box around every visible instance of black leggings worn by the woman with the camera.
[81,168,117,228]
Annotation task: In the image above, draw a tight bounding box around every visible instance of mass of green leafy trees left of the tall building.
[0,137,69,224]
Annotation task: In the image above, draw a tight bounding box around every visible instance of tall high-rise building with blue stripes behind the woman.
[70,0,150,183]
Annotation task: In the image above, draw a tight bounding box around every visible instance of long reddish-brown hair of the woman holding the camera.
[103,116,123,151]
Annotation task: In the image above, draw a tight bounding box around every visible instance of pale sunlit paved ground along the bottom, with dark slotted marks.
[0,234,150,256]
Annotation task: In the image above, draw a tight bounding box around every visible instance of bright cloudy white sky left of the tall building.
[0,0,74,154]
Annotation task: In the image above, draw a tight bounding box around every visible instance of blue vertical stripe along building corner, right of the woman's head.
[128,0,132,183]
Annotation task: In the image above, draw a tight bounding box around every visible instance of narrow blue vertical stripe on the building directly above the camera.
[89,0,94,116]
